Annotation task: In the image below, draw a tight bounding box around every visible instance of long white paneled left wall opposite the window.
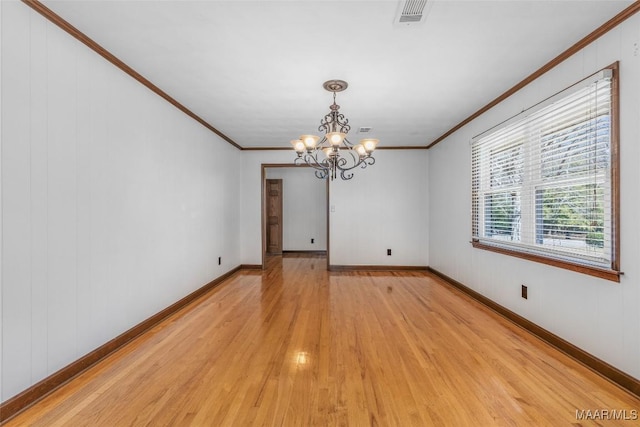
[0,1,241,401]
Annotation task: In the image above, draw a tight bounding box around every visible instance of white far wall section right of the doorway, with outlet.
[329,150,429,267]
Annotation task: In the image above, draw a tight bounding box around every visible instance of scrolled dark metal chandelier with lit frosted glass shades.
[291,80,378,181]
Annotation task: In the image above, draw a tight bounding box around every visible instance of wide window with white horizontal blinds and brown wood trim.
[471,64,619,281]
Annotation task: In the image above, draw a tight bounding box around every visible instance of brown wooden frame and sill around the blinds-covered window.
[470,62,623,282]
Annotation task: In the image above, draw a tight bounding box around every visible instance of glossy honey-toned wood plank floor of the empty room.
[7,255,640,426]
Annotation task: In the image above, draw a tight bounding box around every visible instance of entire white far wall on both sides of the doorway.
[240,149,429,266]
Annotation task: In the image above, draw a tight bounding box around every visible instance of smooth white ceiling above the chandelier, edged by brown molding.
[43,0,632,147]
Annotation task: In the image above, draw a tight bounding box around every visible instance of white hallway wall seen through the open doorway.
[266,167,327,251]
